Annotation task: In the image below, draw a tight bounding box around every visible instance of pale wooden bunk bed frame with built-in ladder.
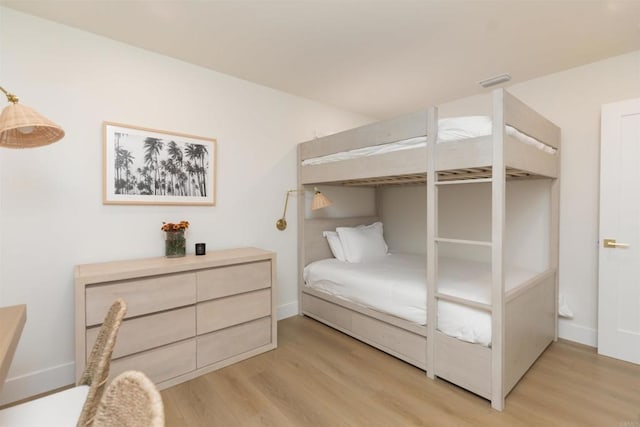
[298,89,560,410]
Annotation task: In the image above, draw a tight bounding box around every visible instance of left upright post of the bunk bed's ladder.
[425,107,438,379]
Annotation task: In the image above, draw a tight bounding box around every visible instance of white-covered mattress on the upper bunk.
[302,116,556,166]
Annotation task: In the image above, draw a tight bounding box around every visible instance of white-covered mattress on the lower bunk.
[304,254,536,346]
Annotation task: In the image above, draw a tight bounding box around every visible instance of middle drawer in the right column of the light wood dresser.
[196,289,271,335]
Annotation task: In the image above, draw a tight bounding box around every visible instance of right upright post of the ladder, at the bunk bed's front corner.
[491,89,506,411]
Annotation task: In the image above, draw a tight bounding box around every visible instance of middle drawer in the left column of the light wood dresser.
[86,306,196,358]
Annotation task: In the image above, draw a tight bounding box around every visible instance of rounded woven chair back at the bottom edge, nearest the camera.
[93,371,164,427]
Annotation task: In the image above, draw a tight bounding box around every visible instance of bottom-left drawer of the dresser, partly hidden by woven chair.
[109,338,196,383]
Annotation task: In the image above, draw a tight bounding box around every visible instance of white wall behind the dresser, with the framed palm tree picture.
[0,7,369,404]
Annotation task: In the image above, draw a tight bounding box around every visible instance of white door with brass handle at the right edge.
[598,99,640,363]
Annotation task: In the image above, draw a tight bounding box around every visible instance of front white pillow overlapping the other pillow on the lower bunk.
[336,222,389,262]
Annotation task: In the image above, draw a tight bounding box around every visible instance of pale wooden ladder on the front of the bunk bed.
[427,89,506,411]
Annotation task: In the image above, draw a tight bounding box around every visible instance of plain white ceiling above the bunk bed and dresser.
[0,0,640,118]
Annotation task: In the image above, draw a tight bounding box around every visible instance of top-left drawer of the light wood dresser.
[85,273,196,326]
